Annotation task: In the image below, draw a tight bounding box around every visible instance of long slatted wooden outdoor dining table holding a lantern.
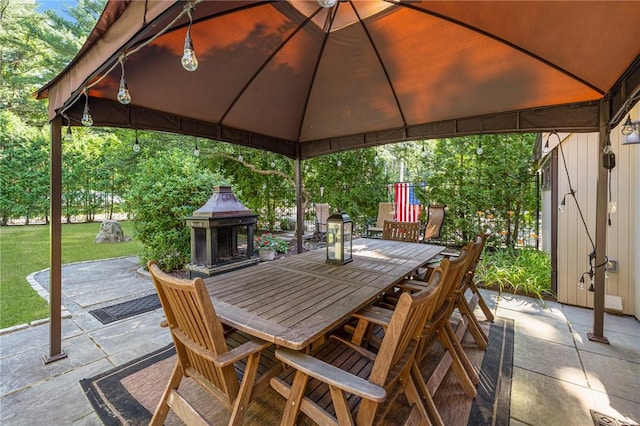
[205,238,444,350]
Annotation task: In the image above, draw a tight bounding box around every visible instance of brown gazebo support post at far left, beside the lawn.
[44,116,67,364]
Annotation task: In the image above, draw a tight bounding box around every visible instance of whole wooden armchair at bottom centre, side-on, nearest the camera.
[271,276,439,425]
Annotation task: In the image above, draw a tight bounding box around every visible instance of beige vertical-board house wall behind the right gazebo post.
[545,102,640,317]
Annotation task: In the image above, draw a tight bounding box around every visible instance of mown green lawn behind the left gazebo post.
[0,222,142,329]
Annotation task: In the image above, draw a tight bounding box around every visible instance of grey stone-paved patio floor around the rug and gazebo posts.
[0,258,640,425]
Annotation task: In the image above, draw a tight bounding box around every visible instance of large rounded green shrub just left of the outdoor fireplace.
[126,151,222,271]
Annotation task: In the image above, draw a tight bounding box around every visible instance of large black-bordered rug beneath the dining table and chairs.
[80,318,513,426]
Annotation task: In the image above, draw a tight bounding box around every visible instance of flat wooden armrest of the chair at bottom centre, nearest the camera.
[276,348,387,402]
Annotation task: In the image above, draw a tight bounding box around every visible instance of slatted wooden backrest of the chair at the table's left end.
[148,261,239,405]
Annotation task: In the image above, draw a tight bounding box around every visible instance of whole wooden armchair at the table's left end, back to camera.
[147,261,282,425]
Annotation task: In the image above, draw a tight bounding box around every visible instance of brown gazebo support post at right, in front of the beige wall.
[587,98,611,344]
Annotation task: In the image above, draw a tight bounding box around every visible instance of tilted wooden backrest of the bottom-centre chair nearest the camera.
[356,267,445,424]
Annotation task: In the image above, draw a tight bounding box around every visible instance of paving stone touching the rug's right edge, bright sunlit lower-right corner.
[513,333,588,388]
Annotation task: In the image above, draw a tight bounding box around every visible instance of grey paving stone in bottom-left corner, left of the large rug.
[0,359,112,426]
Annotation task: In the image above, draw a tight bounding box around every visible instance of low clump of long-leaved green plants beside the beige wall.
[476,248,555,300]
